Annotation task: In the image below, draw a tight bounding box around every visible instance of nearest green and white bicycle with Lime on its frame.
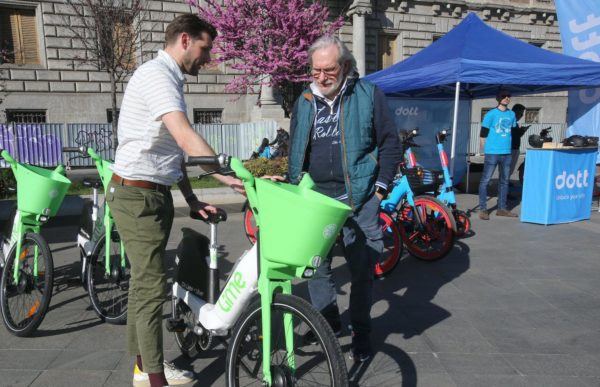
[167,155,351,386]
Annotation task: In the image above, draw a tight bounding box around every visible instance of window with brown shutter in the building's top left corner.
[0,6,40,64]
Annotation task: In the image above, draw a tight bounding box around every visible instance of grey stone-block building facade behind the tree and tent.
[0,0,566,123]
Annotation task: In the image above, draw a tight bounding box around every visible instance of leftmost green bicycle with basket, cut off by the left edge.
[0,148,74,336]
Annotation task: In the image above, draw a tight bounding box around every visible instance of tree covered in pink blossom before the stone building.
[187,0,344,111]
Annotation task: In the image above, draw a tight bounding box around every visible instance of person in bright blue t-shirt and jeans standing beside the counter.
[479,90,517,220]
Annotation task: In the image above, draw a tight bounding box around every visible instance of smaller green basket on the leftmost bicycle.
[15,164,71,216]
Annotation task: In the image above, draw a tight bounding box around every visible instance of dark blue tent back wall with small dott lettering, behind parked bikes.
[388,97,471,185]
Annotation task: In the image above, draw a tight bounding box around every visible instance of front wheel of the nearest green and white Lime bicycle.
[226,293,348,387]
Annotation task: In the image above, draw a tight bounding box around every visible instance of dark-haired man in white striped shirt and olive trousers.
[106,14,243,386]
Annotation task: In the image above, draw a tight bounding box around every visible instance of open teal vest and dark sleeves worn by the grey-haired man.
[289,78,401,211]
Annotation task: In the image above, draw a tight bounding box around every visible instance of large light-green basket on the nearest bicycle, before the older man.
[256,179,352,267]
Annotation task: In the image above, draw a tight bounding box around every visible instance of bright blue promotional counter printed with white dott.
[521,148,598,224]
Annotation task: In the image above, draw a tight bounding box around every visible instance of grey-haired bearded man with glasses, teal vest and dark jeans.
[289,36,401,362]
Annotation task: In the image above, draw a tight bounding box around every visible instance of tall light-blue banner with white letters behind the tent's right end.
[555,0,600,141]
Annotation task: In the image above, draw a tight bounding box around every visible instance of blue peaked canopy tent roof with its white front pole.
[365,13,600,176]
